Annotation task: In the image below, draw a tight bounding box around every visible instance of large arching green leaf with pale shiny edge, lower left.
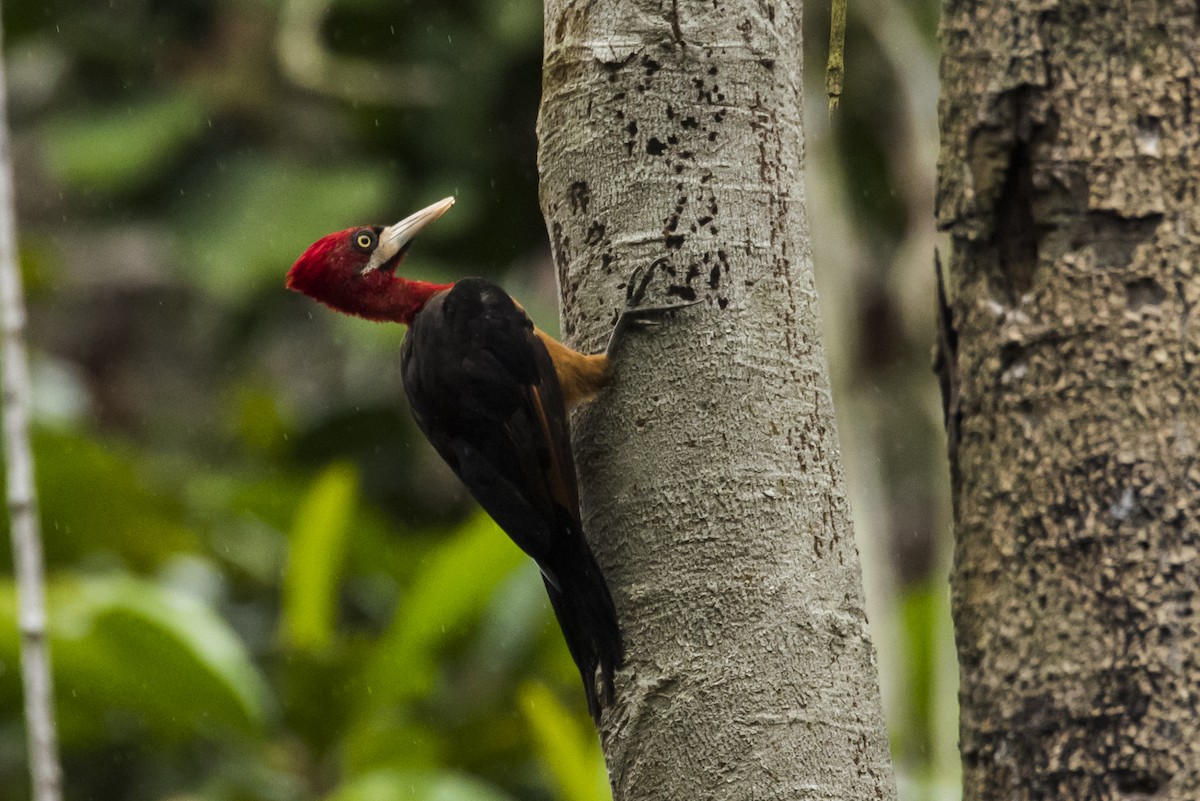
[0,576,270,743]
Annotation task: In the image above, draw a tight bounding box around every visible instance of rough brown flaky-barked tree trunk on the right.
[938,0,1200,801]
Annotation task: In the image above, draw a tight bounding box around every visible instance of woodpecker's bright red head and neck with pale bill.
[287,198,454,324]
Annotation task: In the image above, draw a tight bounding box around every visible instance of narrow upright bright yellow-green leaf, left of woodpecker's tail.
[282,464,358,650]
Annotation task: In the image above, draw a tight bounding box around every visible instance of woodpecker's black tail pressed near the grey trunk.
[542,537,625,725]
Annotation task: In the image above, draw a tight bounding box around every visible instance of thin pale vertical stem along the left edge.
[0,7,62,801]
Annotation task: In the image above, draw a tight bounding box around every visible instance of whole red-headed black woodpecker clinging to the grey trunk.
[287,198,688,724]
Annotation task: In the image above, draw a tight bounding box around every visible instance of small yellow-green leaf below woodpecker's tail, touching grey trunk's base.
[520,681,612,801]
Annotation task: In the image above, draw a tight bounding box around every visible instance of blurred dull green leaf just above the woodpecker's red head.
[180,156,398,299]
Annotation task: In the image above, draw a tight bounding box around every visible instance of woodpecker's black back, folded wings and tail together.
[401,278,623,717]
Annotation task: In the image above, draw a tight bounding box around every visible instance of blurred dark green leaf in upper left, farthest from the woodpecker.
[42,91,205,192]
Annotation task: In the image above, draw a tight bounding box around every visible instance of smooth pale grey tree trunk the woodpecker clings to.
[539,0,894,801]
